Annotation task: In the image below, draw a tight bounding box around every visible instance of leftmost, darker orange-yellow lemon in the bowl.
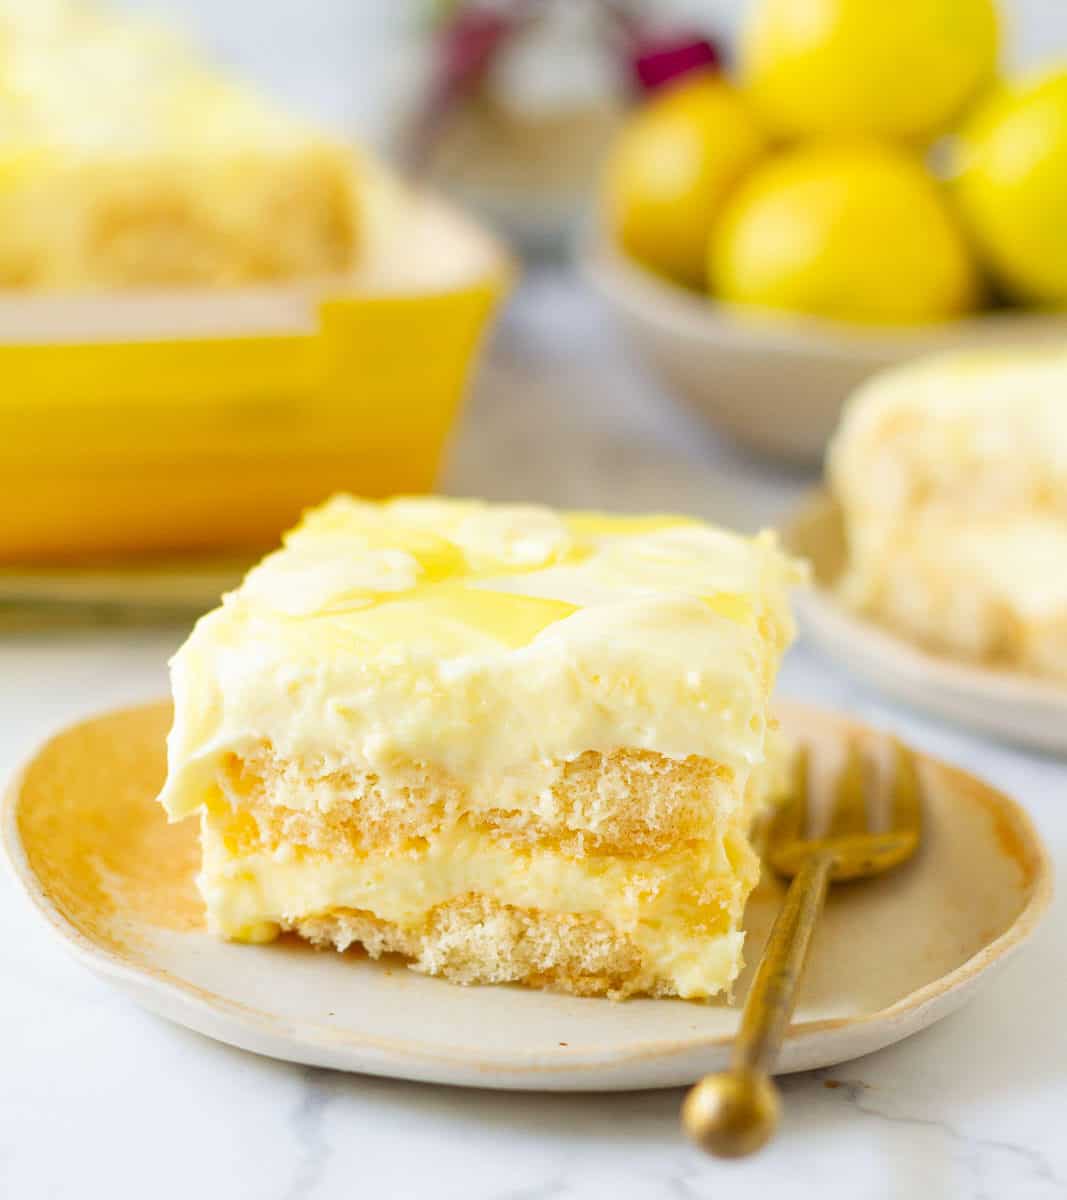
[604,74,766,287]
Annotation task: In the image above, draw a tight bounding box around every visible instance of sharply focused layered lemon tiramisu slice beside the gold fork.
[162,497,795,997]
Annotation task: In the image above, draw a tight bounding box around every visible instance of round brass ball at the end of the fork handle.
[682,1069,781,1158]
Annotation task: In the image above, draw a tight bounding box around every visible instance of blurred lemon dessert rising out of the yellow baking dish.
[0,0,359,289]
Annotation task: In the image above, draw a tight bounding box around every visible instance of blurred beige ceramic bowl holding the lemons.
[579,228,1067,462]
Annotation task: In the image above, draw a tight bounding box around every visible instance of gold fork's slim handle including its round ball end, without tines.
[682,851,834,1158]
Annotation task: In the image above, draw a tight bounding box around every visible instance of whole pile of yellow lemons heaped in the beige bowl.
[605,0,1067,324]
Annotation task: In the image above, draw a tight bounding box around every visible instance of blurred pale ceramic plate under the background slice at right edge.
[784,491,1067,754]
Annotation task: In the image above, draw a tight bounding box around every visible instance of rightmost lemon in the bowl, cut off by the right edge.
[958,71,1067,305]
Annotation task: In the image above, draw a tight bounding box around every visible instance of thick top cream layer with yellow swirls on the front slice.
[161,497,798,818]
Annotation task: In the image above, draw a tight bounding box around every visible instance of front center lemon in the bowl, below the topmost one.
[709,143,979,324]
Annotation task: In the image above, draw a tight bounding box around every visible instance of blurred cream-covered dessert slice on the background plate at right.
[828,349,1067,682]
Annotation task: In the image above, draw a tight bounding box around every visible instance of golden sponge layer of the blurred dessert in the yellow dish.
[0,145,359,289]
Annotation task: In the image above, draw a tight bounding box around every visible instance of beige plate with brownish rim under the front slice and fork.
[2,704,1051,1091]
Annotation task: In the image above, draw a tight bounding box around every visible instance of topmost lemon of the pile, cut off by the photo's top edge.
[741,0,999,140]
